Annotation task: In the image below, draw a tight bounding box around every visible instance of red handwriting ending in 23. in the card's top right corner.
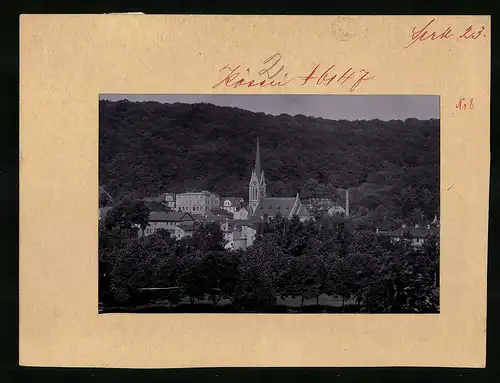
[405,19,487,48]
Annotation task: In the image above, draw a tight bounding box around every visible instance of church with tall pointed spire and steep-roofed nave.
[248,138,311,221]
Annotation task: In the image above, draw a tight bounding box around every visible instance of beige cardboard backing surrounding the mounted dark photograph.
[20,15,490,368]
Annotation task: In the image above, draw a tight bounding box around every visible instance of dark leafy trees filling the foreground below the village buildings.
[99,204,439,313]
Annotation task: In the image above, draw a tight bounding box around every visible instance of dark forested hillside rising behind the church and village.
[99,100,440,230]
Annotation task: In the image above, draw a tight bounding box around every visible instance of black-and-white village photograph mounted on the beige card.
[98,94,440,314]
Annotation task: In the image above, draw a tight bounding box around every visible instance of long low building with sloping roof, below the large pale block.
[143,211,197,239]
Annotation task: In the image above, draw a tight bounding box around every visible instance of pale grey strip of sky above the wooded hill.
[99,94,439,121]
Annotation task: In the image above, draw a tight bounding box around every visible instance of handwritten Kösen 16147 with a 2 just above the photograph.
[212,53,375,92]
